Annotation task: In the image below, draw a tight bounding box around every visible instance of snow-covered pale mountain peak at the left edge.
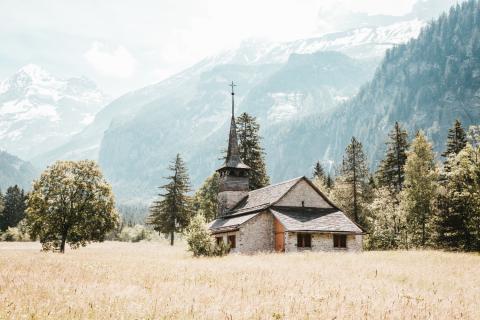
[0,64,106,159]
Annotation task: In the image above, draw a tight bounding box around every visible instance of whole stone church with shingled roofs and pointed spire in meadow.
[209,84,364,253]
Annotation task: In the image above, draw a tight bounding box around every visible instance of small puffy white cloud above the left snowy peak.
[84,41,137,78]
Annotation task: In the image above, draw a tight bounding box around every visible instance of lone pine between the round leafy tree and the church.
[147,154,193,246]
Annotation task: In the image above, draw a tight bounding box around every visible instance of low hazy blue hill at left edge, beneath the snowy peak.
[0,151,38,191]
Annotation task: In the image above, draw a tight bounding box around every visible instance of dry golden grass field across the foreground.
[0,242,480,319]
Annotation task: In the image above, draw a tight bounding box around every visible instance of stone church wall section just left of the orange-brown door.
[237,212,274,253]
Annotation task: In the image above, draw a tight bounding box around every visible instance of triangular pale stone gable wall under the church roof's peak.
[275,180,331,208]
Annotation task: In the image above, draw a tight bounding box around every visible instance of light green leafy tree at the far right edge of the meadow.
[436,144,480,251]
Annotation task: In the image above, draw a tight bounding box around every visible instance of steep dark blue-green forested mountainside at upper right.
[266,0,480,178]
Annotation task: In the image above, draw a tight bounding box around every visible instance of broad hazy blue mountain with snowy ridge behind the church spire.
[35,19,425,200]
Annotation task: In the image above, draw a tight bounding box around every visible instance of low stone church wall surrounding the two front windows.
[285,232,363,252]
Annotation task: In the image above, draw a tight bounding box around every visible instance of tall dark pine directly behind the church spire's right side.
[236,112,270,190]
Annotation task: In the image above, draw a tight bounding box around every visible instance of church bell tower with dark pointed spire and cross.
[217,81,250,217]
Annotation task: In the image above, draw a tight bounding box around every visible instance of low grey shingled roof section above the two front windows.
[270,207,363,234]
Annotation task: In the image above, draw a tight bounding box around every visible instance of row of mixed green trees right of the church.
[314,120,480,251]
